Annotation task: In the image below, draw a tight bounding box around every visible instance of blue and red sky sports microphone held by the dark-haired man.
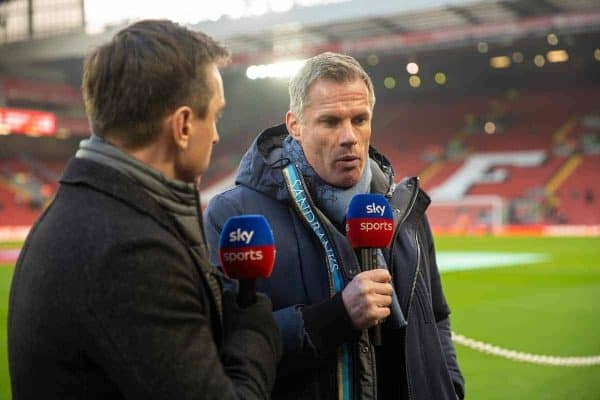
[219,215,275,307]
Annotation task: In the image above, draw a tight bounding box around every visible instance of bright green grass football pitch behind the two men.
[0,237,600,400]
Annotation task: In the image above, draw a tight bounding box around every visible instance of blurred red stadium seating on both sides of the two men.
[0,89,600,231]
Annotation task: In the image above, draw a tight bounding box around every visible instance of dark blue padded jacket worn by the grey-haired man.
[204,125,464,400]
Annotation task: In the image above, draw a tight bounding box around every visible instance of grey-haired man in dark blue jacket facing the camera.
[204,53,464,400]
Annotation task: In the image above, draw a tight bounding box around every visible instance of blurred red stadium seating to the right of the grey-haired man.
[375,88,600,232]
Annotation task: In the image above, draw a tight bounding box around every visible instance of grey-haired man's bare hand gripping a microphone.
[342,269,394,330]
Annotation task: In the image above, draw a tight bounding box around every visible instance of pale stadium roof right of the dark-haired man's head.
[196,0,600,54]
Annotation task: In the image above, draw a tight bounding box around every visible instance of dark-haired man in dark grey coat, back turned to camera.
[8,21,281,400]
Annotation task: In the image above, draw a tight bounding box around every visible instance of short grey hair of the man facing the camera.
[288,52,375,119]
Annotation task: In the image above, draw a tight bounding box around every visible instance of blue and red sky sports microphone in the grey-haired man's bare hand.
[346,194,394,346]
